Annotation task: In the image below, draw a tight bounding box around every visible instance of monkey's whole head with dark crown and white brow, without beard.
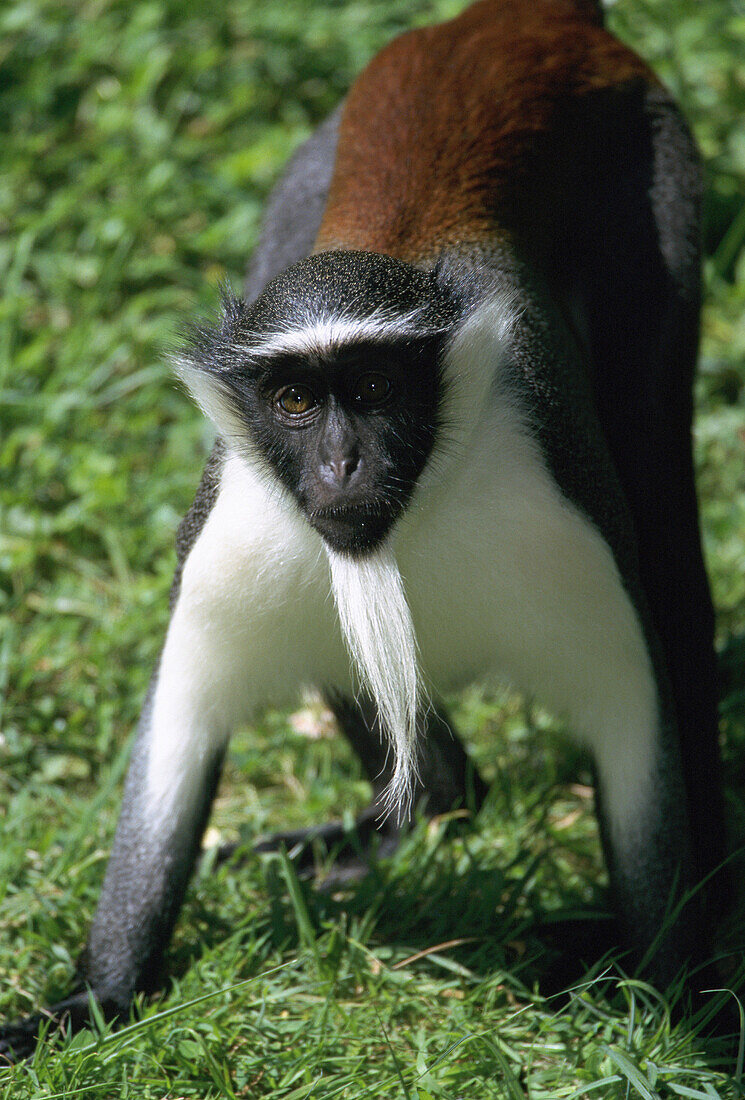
[182,252,451,553]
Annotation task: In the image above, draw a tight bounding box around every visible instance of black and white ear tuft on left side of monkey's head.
[171,284,253,450]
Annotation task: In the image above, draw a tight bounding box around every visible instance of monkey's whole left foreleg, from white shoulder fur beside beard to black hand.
[0,458,349,1057]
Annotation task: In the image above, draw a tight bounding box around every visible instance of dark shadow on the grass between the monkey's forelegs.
[168,822,624,997]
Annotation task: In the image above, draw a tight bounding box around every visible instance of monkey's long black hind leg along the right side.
[590,90,732,915]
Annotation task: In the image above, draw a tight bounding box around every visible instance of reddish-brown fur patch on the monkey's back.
[317,0,654,262]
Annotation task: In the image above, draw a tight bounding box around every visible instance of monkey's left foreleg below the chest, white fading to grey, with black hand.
[0,642,224,1060]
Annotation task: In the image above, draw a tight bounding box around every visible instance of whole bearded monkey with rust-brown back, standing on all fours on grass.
[0,0,725,1057]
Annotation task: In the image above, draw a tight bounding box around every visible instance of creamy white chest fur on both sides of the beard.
[149,309,658,849]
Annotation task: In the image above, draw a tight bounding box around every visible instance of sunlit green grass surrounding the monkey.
[0,0,745,1100]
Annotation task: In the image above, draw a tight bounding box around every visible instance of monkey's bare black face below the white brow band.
[241,339,439,552]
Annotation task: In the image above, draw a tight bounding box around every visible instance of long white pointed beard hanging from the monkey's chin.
[327,546,425,821]
